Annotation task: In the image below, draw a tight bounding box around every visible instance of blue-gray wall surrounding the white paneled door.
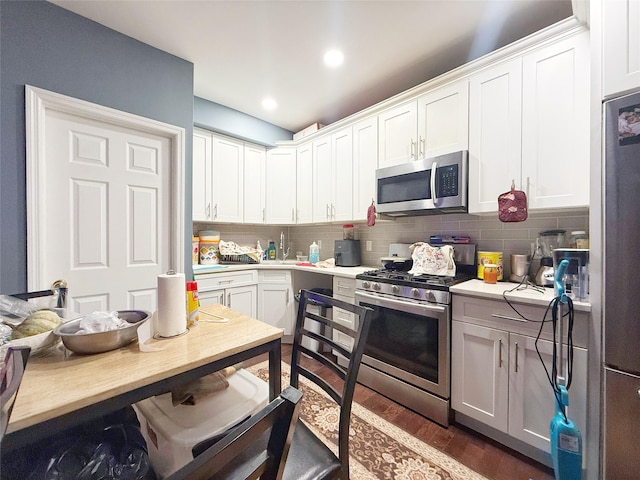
[0,0,193,294]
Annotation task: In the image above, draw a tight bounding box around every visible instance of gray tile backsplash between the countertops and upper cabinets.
[193,209,589,276]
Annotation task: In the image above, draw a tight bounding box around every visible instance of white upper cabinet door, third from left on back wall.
[244,145,267,223]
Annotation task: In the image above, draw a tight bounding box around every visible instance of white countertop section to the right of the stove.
[450,279,591,312]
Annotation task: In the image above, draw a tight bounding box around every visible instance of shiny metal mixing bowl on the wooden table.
[53,310,151,354]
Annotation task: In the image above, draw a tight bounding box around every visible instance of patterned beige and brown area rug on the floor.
[246,362,487,480]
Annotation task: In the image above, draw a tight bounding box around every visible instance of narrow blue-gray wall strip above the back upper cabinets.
[193,97,293,147]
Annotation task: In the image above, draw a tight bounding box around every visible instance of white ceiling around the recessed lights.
[50,0,572,132]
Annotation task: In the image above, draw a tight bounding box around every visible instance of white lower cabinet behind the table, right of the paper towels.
[198,270,258,320]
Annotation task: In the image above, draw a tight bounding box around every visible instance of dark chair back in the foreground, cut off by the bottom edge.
[167,387,302,480]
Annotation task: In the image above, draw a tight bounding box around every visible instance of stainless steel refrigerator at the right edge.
[603,92,640,480]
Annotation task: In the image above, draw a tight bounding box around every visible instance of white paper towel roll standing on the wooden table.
[156,272,187,337]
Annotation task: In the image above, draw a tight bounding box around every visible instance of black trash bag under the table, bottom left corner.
[2,407,156,480]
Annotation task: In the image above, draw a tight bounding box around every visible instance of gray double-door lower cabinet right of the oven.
[451,301,587,453]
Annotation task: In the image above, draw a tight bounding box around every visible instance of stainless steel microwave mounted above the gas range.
[376,150,469,216]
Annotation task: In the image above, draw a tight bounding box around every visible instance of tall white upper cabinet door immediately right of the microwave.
[469,58,522,213]
